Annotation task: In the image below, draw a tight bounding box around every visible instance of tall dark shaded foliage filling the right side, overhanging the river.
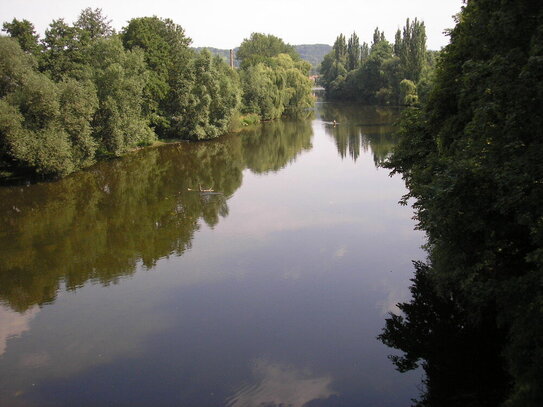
[381,0,543,407]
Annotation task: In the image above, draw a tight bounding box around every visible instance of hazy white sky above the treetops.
[0,0,463,49]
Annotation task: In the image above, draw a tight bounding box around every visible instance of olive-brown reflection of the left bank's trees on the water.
[0,121,312,312]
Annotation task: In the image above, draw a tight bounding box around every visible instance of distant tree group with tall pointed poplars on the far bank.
[320,18,436,106]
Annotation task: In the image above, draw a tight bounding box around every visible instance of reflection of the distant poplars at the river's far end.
[320,103,399,165]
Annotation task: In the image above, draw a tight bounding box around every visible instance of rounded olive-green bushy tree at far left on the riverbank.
[0,38,97,176]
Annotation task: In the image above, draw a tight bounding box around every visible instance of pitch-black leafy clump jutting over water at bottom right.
[379,262,510,407]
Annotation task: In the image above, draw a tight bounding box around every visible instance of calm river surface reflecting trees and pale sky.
[0,103,424,407]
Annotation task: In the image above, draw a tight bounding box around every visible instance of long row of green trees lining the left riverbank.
[0,8,313,176]
